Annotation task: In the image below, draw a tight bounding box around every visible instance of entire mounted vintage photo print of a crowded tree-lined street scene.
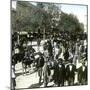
[11,0,88,90]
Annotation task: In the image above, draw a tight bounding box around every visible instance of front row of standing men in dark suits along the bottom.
[38,54,87,87]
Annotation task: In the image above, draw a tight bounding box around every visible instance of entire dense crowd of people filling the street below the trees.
[12,33,88,87]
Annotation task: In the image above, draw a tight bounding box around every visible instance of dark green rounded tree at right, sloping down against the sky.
[59,12,84,33]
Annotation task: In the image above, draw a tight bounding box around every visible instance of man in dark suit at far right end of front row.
[78,61,87,85]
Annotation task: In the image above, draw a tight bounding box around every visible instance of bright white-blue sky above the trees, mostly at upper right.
[12,1,87,31]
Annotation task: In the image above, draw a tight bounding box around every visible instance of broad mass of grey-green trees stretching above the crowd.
[12,1,84,37]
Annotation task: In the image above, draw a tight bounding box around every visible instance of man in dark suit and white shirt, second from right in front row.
[66,59,76,86]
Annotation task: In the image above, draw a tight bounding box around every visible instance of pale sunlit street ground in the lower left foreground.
[15,63,54,90]
